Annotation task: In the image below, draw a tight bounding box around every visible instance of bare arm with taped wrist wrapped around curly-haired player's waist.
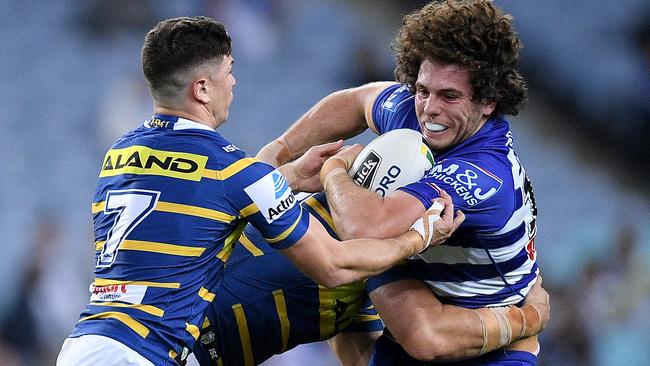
[370,277,550,361]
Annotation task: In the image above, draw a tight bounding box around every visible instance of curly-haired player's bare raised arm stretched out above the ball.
[257,81,394,167]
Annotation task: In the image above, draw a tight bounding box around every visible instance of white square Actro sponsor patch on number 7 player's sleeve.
[244,170,296,224]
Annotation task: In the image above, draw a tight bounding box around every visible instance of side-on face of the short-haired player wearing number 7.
[209,55,237,127]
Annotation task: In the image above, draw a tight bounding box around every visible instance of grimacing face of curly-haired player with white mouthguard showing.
[415,60,494,152]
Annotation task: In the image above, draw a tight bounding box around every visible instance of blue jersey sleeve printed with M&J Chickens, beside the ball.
[399,158,514,232]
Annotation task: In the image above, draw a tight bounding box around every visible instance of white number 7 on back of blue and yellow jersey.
[97,189,160,267]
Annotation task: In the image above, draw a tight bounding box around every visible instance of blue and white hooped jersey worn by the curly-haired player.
[368,85,538,308]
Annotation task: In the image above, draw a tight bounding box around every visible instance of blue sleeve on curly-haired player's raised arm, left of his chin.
[372,84,419,135]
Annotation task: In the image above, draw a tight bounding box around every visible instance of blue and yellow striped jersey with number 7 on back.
[71,115,309,365]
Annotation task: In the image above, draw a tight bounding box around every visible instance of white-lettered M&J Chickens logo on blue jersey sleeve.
[425,160,503,206]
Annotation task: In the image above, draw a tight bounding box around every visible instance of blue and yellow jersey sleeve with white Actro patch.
[226,158,309,249]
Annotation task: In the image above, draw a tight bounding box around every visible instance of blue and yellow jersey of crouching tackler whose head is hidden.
[194,193,383,366]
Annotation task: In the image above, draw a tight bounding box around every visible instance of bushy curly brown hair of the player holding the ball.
[392,0,528,115]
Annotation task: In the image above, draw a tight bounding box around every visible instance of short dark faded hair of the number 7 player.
[142,16,231,99]
